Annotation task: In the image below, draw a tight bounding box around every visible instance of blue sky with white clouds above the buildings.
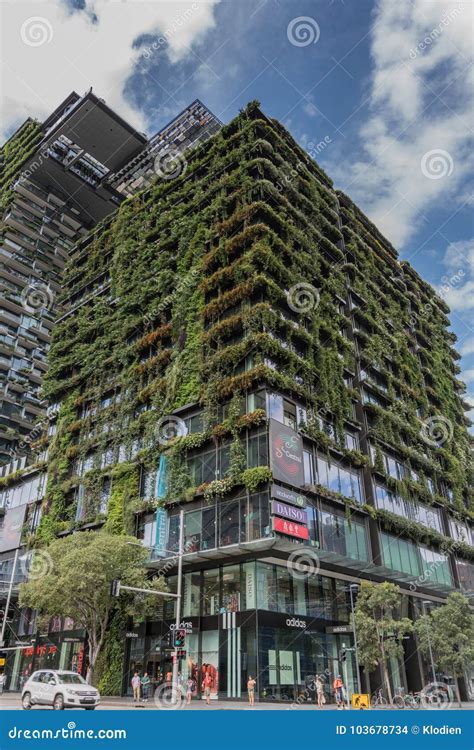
[0,0,474,420]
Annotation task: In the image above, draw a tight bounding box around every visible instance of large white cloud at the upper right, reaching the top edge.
[332,0,473,245]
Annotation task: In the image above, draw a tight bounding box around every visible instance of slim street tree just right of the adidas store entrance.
[354,581,413,703]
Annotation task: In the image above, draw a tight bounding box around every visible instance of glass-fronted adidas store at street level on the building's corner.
[124,561,362,702]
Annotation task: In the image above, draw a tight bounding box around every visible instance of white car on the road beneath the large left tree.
[21,669,100,711]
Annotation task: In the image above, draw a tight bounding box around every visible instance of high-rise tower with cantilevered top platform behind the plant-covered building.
[0,91,220,464]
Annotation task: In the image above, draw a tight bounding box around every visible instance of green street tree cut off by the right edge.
[415,591,474,705]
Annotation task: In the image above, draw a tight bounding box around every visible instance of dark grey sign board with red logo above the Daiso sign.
[270,419,304,487]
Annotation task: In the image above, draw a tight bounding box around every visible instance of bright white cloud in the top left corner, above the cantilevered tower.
[1,0,220,140]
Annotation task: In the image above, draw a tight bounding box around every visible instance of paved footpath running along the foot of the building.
[0,693,474,711]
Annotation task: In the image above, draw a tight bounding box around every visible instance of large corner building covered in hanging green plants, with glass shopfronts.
[16,103,473,700]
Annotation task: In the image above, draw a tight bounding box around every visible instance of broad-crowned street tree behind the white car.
[19,531,166,682]
